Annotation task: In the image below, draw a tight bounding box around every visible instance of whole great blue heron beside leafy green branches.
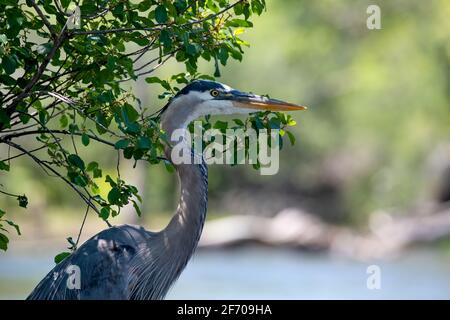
[28,80,304,299]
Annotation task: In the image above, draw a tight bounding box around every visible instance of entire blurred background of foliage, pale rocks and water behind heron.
[0,0,450,299]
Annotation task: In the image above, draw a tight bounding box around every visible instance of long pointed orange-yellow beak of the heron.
[230,90,307,111]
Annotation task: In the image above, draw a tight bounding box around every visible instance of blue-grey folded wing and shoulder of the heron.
[28,225,154,300]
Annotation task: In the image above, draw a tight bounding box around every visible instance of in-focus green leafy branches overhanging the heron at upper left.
[0,0,284,252]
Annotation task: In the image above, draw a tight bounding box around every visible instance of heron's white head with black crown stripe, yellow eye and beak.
[167,80,306,116]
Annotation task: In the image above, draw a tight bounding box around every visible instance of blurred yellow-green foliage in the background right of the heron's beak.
[211,0,450,223]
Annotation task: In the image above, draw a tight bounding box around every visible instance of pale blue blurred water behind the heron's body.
[0,247,450,299]
